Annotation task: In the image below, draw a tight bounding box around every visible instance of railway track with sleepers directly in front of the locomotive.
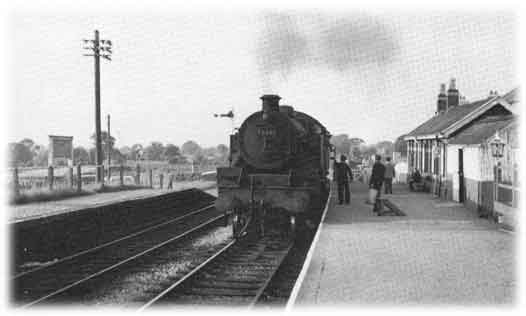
[140,236,293,310]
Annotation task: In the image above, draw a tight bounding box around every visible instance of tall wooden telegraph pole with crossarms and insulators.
[84,30,112,183]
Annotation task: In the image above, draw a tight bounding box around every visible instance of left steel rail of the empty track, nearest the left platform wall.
[11,204,214,280]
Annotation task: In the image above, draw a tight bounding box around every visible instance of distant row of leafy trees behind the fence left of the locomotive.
[8,131,229,167]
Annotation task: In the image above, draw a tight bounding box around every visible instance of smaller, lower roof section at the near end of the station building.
[448,114,515,145]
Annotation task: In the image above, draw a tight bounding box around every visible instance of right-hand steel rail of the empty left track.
[21,214,225,308]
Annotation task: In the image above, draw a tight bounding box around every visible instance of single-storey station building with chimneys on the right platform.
[404,79,520,227]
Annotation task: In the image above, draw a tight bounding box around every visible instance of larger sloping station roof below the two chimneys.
[405,97,493,137]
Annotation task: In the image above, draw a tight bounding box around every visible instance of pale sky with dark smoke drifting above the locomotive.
[6,9,519,147]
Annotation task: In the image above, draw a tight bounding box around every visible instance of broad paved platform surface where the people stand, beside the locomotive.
[294,183,516,308]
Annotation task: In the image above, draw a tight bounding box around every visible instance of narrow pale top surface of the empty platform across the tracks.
[8,181,214,222]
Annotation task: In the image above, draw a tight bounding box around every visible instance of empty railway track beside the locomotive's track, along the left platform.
[11,205,224,307]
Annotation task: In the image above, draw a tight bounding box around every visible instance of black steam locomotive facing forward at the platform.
[216,95,332,237]
